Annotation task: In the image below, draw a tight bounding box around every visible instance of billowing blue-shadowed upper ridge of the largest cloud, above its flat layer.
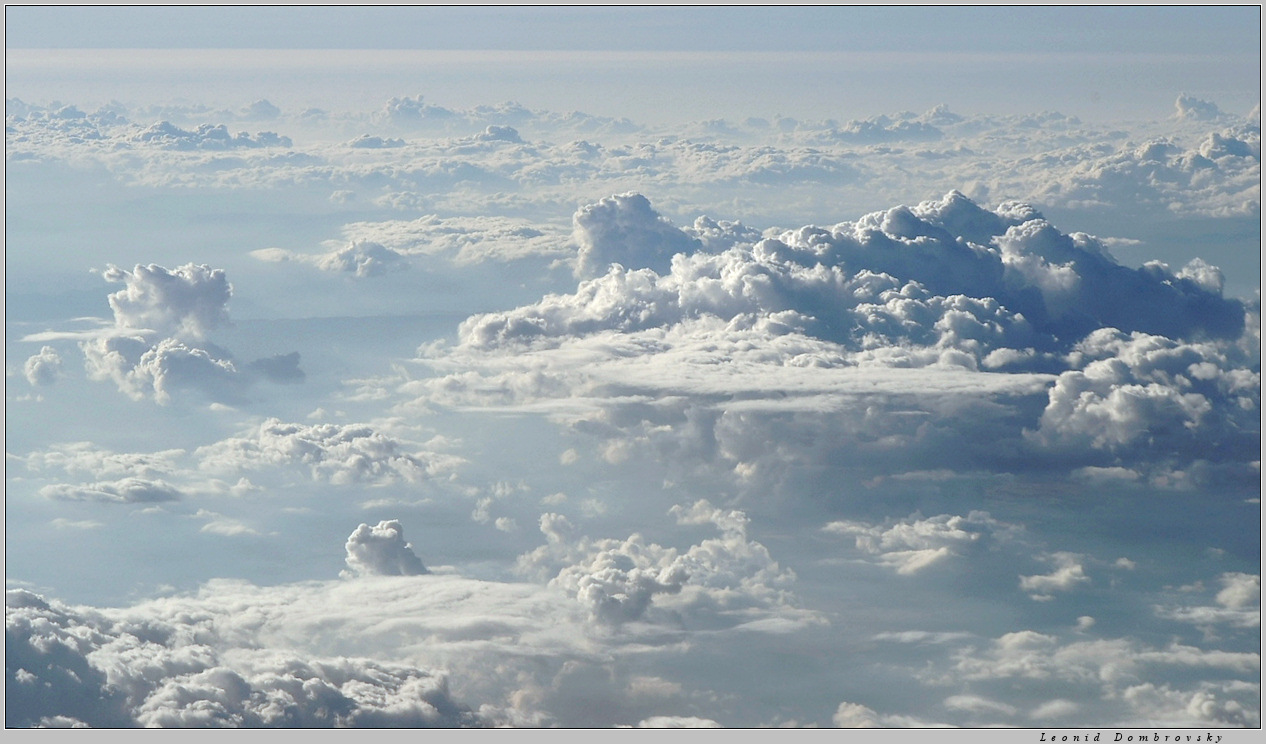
[462,192,1244,350]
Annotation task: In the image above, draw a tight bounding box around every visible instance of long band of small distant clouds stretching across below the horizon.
[6,96,1261,223]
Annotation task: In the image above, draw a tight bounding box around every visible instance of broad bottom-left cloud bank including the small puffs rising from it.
[5,511,822,728]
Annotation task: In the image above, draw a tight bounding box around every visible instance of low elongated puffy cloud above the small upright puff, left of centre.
[195,419,461,483]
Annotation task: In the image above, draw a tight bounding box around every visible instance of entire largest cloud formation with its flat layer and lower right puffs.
[412,192,1260,487]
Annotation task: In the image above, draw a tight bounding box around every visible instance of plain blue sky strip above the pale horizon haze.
[5,6,1261,54]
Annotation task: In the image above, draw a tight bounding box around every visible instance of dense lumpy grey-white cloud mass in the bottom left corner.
[5,590,480,728]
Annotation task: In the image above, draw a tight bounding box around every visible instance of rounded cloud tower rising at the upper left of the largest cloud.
[572,194,699,276]
